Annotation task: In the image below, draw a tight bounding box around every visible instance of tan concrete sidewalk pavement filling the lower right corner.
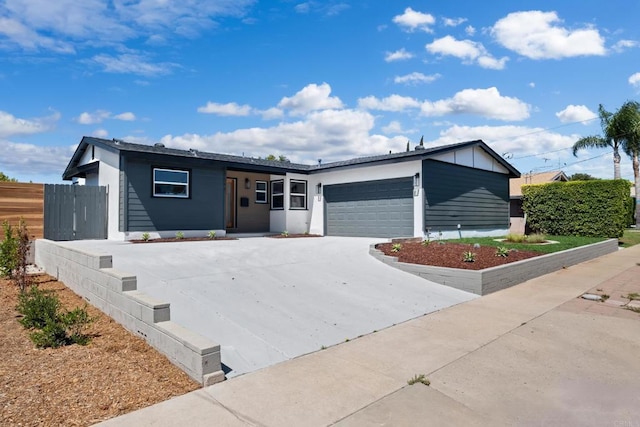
[96,245,640,427]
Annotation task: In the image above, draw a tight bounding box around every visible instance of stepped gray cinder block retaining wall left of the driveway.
[35,239,224,386]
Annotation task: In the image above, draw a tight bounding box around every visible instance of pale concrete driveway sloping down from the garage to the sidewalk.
[62,237,477,376]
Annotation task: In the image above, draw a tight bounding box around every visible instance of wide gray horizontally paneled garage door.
[323,177,413,237]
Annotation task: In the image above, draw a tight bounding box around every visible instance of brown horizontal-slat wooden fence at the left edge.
[0,182,44,240]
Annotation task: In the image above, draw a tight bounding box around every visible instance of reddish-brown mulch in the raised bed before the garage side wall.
[376,242,543,270]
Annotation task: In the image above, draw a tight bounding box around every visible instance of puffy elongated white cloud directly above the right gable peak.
[422,87,531,121]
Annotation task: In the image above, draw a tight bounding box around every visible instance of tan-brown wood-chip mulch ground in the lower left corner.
[0,275,200,426]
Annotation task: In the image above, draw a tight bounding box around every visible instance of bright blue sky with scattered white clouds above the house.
[0,0,640,183]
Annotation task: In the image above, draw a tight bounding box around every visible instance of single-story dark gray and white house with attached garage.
[63,137,520,240]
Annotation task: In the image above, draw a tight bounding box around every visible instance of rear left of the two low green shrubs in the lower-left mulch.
[16,286,60,329]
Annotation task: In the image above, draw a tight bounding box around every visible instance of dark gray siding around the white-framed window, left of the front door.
[123,159,225,231]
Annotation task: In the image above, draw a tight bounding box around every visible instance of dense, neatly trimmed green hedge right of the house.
[522,179,631,238]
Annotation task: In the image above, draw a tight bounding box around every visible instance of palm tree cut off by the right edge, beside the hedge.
[611,101,640,227]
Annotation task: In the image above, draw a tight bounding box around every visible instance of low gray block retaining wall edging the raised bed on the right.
[369,239,618,295]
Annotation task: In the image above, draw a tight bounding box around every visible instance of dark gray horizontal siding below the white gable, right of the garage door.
[422,160,509,232]
